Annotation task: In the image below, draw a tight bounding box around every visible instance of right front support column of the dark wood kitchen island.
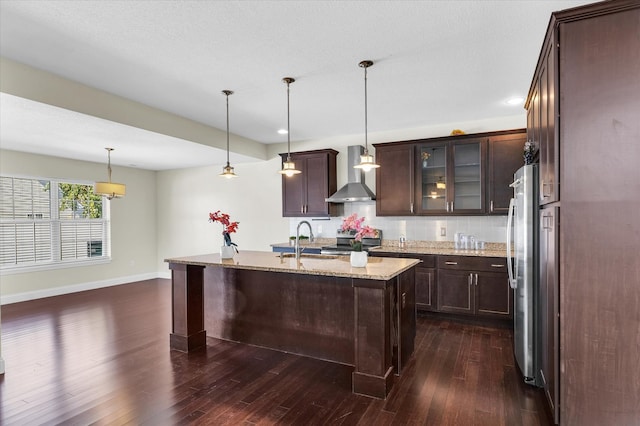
[352,279,394,399]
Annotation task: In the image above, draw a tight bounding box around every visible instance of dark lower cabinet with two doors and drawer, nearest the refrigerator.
[437,256,513,319]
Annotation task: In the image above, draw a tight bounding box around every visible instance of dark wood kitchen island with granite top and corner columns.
[165,251,419,398]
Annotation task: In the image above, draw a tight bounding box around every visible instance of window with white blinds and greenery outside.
[0,176,111,272]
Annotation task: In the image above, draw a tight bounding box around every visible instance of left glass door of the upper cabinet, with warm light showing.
[416,143,444,214]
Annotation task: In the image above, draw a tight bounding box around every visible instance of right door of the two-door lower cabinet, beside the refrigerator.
[473,272,513,318]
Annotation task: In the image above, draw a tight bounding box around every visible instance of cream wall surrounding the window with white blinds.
[0,150,158,303]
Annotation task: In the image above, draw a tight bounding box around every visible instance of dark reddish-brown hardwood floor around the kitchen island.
[0,280,548,426]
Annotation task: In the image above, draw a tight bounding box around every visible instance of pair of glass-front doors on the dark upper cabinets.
[416,139,487,215]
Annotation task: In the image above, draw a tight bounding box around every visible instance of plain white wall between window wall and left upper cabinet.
[157,157,289,276]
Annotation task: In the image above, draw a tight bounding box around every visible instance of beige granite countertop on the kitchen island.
[164,250,420,281]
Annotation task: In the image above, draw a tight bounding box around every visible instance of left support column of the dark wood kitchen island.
[169,263,207,352]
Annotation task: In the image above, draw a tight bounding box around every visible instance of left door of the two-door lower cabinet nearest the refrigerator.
[437,269,474,314]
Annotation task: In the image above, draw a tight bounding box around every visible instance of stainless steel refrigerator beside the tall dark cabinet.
[507,164,540,386]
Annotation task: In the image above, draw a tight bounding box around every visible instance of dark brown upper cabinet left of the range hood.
[280,149,338,217]
